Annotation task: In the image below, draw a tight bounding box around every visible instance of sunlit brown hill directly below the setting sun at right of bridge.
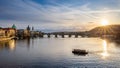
[89,25,120,36]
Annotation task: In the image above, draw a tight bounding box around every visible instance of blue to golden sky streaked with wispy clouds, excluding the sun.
[0,0,120,31]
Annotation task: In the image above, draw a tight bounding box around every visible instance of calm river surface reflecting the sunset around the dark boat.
[0,37,120,68]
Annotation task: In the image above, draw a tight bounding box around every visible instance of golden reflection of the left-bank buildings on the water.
[0,40,16,50]
